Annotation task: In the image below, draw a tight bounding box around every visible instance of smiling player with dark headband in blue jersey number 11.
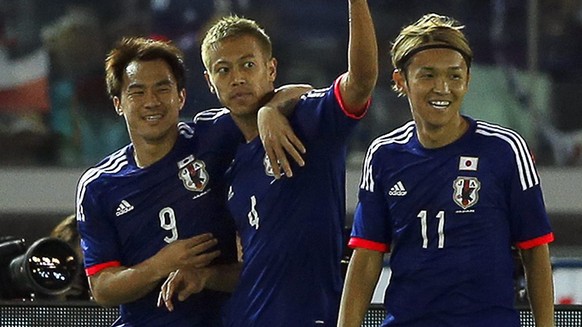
[338,14,554,327]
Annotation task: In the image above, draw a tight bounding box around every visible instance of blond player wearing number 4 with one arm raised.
[160,0,378,327]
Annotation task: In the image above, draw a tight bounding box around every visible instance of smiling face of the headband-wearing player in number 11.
[393,48,469,133]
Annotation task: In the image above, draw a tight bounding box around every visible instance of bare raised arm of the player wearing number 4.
[340,0,378,116]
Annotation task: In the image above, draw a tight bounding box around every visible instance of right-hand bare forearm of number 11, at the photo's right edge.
[521,244,555,327]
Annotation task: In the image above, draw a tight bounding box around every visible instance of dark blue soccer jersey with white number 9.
[77,109,242,327]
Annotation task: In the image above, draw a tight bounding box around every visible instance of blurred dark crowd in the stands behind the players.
[0,0,582,167]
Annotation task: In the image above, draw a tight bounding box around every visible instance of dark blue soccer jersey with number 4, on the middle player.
[226,77,370,327]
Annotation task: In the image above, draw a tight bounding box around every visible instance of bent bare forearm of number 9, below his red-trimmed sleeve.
[89,260,167,307]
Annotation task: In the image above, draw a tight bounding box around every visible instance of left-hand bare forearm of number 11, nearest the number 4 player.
[338,249,383,327]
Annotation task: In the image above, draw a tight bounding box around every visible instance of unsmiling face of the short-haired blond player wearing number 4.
[205,35,277,119]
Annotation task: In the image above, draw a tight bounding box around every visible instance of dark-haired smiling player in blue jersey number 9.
[76,38,310,327]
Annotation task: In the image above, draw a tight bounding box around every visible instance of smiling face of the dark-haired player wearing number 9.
[113,59,185,143]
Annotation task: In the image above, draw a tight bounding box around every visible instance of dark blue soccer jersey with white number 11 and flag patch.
[350,117,553,327]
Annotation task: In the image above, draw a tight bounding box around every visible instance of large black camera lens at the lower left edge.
[0,237,79,299]
